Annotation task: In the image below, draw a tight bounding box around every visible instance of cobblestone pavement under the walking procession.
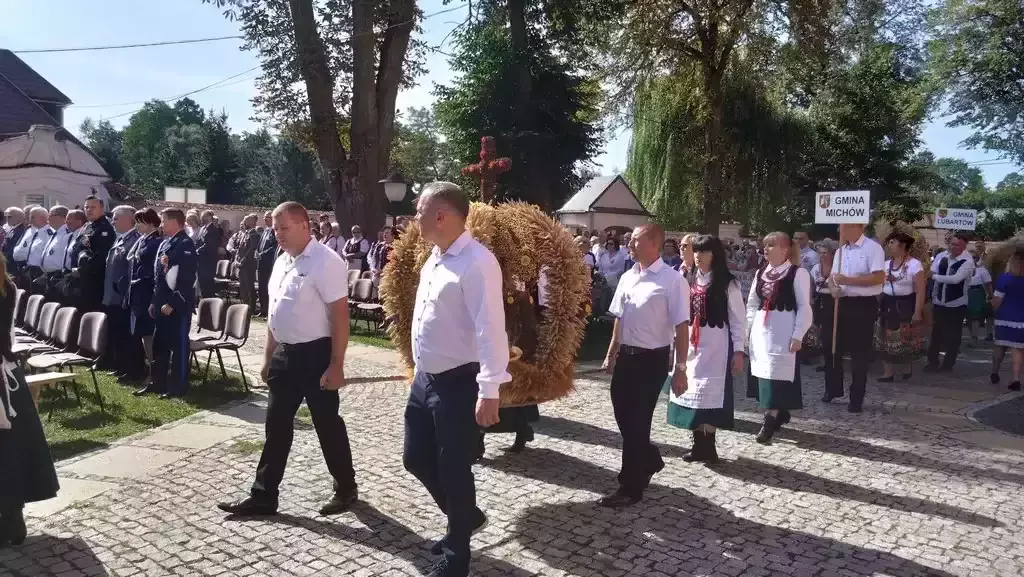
[0,327,1024,577]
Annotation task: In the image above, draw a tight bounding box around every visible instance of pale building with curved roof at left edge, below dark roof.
[0,125,111,208]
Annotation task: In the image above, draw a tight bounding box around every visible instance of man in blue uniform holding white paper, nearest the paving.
[135,208,199,399]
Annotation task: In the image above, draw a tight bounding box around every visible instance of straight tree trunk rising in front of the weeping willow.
[700,64,725,236]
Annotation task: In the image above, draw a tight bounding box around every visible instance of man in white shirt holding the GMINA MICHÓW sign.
[821,224,886,413]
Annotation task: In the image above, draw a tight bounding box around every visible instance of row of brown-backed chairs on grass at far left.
[12,289,109,416]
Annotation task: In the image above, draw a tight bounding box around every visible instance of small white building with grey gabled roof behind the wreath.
[555,175,654,231]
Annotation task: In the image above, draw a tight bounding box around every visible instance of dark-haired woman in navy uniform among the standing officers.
[128,208,164,390]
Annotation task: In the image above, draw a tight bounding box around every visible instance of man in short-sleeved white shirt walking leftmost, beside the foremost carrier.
[217,201,358,516]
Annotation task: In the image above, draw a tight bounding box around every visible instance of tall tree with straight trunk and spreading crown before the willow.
[608,0,833,234]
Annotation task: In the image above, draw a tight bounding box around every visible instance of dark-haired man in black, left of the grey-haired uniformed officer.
[72,196,117,313]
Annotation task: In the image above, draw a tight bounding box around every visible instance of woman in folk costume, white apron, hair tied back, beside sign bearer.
[746,233,813,444]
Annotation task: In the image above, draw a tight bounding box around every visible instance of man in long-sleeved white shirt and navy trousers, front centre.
[403,182,512,577]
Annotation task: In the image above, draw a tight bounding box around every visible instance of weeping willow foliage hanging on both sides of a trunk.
[627,61,811,234]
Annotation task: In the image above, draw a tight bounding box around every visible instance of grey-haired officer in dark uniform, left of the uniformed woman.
[103,205,143,380]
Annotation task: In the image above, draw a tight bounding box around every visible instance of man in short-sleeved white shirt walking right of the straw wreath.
[598,224,690,507]
